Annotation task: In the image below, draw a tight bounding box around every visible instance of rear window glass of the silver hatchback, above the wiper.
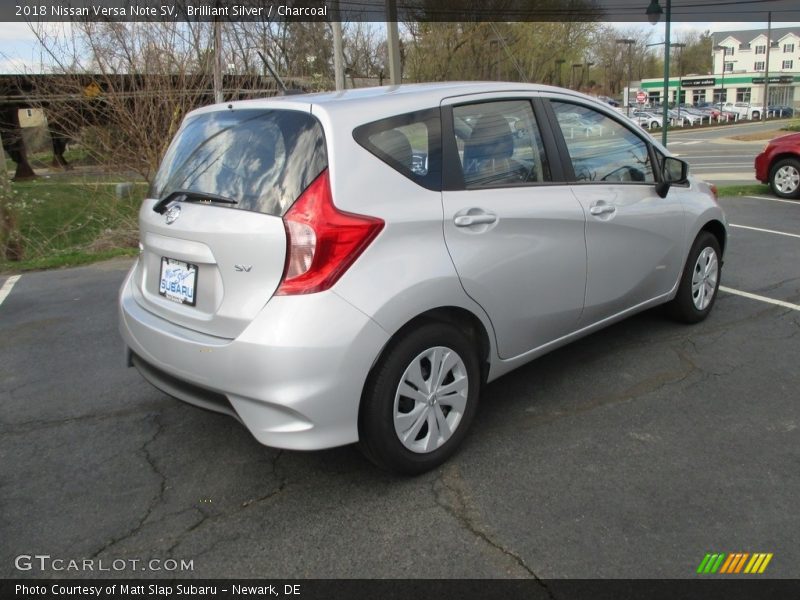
[151,109,328,216]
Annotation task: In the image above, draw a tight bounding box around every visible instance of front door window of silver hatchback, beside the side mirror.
[552,101,655,183]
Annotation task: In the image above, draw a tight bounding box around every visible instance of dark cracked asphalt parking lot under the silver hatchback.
[0,196,800,578]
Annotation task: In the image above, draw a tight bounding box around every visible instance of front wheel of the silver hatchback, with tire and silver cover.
[667,231,721,323]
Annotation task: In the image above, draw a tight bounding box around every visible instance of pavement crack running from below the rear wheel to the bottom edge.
[432,464,554,598]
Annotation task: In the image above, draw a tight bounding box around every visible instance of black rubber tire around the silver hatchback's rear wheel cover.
[359,322,481,475]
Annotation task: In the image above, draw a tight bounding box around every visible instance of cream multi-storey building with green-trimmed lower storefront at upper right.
[640,27,800,108]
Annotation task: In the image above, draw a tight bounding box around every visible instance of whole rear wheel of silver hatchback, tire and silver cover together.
[359,323,480,475]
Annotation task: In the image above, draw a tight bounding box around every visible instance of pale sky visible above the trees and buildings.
[0,20,800,73]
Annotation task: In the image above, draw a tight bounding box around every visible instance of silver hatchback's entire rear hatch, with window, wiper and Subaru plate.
[135,105,327,338]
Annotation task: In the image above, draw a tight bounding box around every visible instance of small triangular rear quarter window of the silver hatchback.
[353,108,442,191]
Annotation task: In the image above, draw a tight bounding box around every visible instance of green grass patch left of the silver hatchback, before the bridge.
[0,178,147,272]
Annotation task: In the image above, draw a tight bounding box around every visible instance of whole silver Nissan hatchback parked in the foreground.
[119,83,727,474]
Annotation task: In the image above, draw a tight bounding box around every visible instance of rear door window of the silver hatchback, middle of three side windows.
[453,100,550,189]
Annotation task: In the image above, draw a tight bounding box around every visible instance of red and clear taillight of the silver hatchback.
[275,169,384,296]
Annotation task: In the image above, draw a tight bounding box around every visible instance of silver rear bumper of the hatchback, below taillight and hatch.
[119,262,388,450]
